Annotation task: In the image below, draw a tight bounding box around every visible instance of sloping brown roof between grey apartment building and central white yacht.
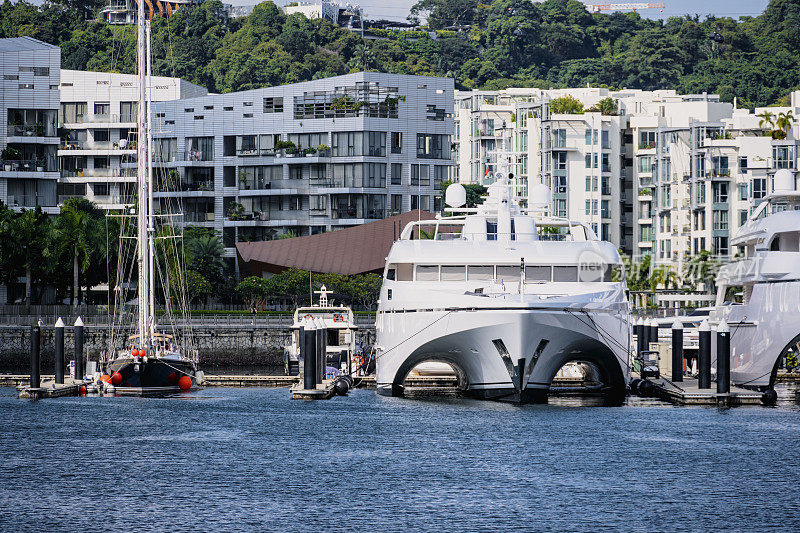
[236,210,435,275]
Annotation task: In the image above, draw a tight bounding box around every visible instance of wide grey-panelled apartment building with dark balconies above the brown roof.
[154,72,453,264]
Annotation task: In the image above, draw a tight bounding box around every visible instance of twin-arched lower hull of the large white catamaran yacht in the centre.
[376,308,630,403]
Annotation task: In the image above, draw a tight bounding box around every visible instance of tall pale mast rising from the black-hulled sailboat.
[136,1,150,347]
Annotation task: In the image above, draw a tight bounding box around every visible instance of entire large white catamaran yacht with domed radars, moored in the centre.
[375,172,631,402]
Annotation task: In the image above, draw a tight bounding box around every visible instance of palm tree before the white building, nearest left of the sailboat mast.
[55,199,91,306]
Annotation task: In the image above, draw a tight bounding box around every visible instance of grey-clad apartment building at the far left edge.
[0,37,61,213]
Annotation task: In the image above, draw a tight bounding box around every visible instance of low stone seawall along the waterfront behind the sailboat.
[0,326,375,372]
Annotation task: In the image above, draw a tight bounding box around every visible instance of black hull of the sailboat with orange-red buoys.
[105,357,197,392]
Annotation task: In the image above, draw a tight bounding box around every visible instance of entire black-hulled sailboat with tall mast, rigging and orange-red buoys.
[101,2,202,395]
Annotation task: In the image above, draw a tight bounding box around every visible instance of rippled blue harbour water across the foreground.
[0,388,800,531]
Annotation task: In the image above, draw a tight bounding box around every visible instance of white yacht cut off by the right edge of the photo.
[710,170,800,390]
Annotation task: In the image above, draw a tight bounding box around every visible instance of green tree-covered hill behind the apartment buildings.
[0,0,800,107]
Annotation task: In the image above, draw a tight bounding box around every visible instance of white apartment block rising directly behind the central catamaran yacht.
[454,88,633,250]
